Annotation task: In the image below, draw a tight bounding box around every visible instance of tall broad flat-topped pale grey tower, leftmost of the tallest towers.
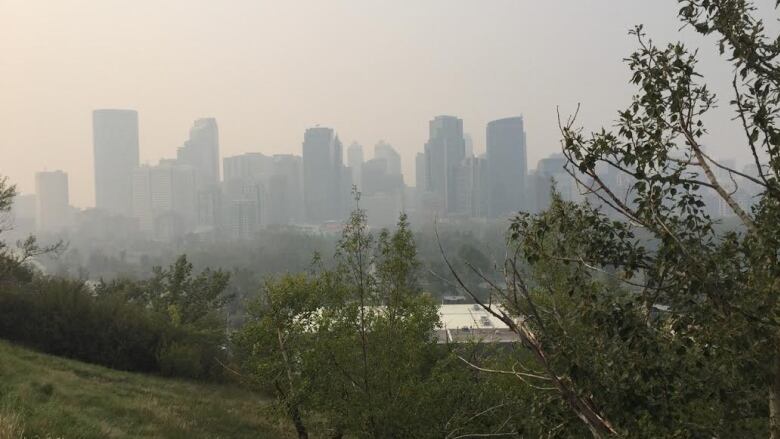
[92,110,138,216]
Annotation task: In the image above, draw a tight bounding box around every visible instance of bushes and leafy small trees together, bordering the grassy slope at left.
[0,248,228,380]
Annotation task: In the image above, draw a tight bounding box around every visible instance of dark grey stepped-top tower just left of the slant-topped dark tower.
[425,116,466,212]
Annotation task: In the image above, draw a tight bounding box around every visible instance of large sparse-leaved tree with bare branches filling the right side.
[444,0,780,438]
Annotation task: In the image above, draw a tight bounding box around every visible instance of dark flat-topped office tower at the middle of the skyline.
[303,127,349,223]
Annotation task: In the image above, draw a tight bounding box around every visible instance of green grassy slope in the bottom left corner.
[0,341,287,439]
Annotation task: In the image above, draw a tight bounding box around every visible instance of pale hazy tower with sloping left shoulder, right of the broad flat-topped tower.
[176,117,219,185]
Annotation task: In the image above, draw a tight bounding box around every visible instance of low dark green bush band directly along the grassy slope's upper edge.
[0,278,229,379]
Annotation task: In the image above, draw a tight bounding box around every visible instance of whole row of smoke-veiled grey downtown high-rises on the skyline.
[9,109,760,241]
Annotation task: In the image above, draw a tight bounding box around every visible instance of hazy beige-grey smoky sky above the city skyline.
[0,0,756,207]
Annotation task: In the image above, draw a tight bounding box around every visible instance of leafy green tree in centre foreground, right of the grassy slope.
[234,199,472,438]
